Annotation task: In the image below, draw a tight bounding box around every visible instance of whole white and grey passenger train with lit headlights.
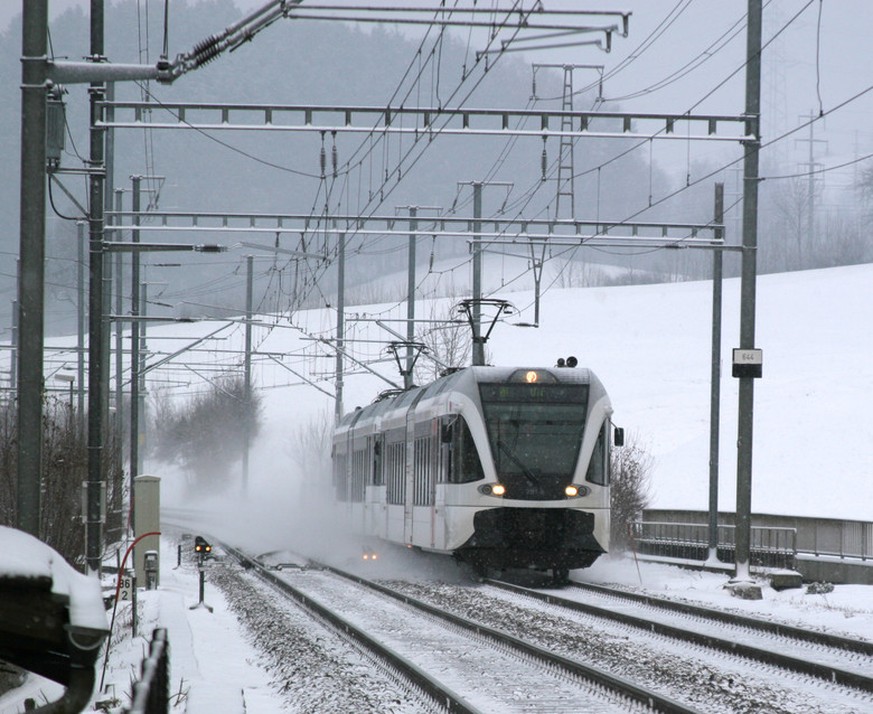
[333,367,612,579]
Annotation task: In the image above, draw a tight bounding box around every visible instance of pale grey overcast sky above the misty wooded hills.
[6,0,873,191]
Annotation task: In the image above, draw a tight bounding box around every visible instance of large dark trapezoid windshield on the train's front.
[479,384,588,499]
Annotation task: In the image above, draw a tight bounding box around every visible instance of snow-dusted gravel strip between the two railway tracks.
[389,581,873,714]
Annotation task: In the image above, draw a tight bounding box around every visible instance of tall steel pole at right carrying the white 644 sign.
[734,0,762,581]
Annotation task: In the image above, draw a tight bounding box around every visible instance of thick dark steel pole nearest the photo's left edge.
[16,0,48,537]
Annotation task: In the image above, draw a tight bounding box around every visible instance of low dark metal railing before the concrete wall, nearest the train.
[631,521,797,569]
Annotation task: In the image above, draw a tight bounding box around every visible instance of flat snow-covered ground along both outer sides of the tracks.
[0,533,873,714]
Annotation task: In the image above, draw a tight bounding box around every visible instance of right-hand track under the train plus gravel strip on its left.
[392,581,873,714]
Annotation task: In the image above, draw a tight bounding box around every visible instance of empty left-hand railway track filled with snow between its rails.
[226,547,698,714]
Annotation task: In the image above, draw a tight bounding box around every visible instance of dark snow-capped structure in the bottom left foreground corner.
[0,526,108,711]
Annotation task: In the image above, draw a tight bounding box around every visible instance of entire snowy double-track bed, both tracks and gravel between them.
[172,524,873,714]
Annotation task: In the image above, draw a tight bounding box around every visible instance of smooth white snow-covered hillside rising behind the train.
[121,265,873,520]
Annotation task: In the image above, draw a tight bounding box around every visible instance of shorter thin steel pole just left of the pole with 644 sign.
[709,183,724,563]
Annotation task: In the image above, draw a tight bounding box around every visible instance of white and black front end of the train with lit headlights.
[450,368,612,579]
